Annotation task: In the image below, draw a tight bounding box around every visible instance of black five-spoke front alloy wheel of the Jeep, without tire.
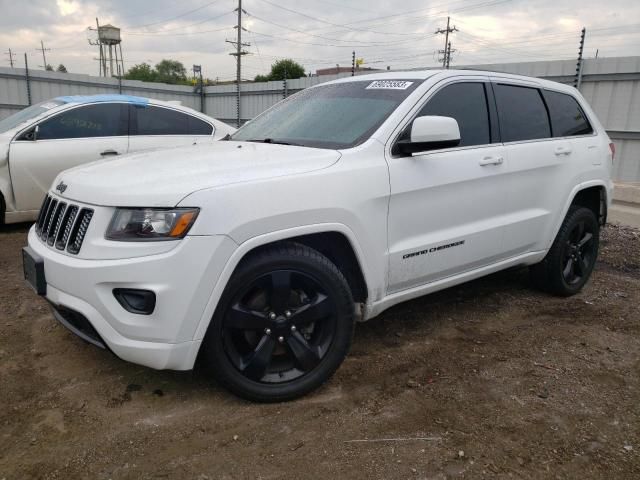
[222,270,336,383]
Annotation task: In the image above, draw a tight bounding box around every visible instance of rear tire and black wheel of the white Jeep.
[530,205,600,297]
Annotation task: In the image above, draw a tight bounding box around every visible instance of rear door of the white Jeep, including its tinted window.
[493,79,577,256]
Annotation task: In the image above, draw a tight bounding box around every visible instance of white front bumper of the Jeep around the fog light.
[29,227,237,370]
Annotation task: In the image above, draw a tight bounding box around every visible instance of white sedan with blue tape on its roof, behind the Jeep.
[0,95,235,224]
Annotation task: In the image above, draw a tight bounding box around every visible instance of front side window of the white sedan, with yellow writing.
[37,103,127,140]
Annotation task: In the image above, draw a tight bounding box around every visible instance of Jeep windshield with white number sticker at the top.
[231,80,420,149]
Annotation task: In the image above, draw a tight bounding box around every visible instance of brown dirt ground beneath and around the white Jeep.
[0,226,640,480]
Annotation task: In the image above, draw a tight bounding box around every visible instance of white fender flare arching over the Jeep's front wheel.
[188,223,373,344]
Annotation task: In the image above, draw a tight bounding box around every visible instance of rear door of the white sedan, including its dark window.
[129,105,214,152]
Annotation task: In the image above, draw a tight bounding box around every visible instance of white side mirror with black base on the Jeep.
[398,115,460,154]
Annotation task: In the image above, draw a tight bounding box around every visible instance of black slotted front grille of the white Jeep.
[36,195,93,255]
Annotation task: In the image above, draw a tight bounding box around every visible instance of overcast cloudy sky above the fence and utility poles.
[0,0,640,80]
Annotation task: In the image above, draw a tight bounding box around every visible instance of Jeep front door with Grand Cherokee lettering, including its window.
[388,80,508,293]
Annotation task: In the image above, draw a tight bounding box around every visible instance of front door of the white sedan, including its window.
[9,103,128,211]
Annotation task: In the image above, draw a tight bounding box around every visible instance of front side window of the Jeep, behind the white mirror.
[418,82,491,147]
